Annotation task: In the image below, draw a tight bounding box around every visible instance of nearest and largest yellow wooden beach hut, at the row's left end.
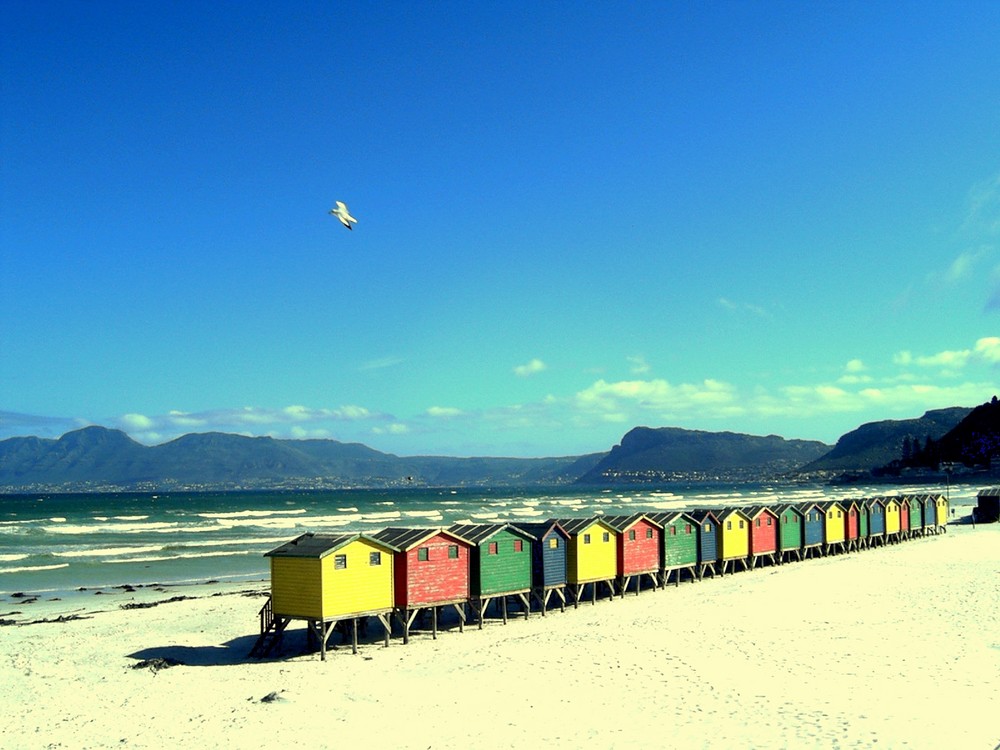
[253,533,396,659]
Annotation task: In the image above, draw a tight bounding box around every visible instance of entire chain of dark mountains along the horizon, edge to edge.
[0,399,1000,492]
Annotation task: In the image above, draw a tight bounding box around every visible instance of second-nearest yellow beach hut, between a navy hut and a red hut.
[556,518,618,607]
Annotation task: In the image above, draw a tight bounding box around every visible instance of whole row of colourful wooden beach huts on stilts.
[251,494,948,659]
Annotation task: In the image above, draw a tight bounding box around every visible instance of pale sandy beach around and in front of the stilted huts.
[0,524,1000,750]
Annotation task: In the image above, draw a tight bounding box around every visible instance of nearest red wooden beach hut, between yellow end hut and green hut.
[372,528,472,643]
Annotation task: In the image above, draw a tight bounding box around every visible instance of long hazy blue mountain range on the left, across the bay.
[0,427,603,490]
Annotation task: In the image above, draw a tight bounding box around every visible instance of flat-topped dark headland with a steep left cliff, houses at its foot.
[578,427,830,484]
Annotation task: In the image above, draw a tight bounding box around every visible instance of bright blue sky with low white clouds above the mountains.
[0,2,1000,456]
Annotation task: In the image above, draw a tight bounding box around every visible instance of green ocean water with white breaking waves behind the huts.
[0,484,977,601]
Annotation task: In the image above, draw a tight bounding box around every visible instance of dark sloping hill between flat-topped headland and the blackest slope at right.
[799,406,972,474]
